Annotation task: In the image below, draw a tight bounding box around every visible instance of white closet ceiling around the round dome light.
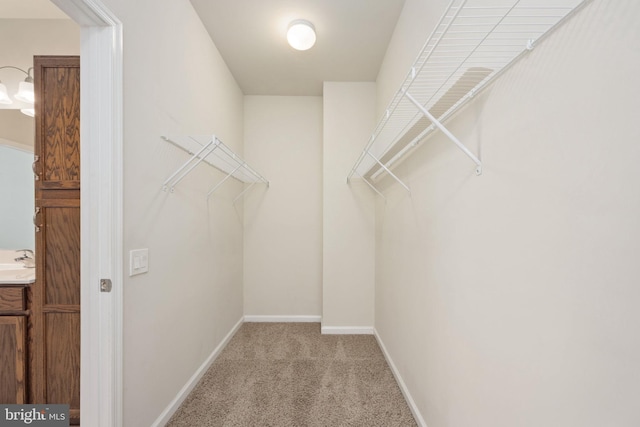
[190,0,405,95]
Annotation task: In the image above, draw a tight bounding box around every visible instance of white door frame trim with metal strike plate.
[51,0,123,427]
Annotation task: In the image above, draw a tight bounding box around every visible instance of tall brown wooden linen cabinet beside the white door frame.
[28,56,80,425]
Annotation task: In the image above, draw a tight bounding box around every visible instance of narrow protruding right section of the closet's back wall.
[322,82,376,332]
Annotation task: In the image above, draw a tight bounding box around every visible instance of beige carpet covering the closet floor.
[167,323,416,427]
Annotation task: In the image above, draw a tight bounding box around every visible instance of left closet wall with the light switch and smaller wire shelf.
[97,0,243,426]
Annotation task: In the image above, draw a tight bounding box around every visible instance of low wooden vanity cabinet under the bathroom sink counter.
[0,285,27,403]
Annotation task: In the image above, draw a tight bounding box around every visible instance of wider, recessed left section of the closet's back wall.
[244,96,322,316]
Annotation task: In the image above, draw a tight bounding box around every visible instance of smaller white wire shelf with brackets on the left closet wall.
[162,135,269,203]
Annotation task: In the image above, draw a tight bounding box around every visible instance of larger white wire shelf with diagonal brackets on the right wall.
[347,0,589,194]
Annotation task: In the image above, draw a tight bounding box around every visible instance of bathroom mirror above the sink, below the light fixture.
[0,109,35,249]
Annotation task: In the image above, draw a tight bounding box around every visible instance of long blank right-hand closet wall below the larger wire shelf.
[376,0,640,427]
